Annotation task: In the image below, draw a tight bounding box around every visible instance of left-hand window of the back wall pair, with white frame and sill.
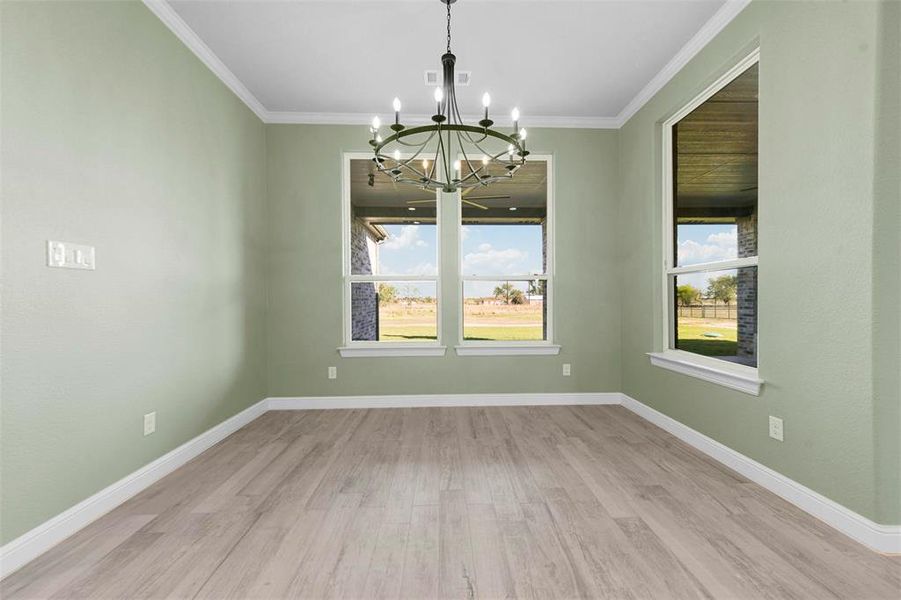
[340,154,444,356]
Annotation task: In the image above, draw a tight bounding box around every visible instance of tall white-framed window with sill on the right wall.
[652,52,760,393]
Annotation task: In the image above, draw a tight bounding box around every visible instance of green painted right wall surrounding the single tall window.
[619,2,901,523]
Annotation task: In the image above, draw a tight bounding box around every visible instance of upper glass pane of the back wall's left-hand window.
[350,159,438,276]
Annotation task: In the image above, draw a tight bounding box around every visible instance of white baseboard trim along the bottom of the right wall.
[621,394,901,554]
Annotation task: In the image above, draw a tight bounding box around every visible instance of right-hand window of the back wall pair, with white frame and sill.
[458,156,559,354]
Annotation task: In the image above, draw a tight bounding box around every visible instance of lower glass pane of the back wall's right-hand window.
[463,280,547,341]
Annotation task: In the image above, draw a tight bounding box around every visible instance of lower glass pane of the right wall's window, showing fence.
[673,267,757,367]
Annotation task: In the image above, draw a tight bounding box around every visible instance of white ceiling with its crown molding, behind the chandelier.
[155,0,745,126]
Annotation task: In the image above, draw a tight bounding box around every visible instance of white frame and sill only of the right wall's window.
[648,47,764,396]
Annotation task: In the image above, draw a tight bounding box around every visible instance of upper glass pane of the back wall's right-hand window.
[460,161,547,277]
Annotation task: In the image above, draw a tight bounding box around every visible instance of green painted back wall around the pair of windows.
[266,125,620,396]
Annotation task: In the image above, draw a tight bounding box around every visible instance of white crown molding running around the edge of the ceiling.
[143,0,751,129]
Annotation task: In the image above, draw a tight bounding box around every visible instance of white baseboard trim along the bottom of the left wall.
[0,400,266,579]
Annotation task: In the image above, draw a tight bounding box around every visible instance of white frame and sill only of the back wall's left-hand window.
[338,152,446,358]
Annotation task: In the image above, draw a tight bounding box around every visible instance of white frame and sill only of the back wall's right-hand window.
[454,153,560,356]
